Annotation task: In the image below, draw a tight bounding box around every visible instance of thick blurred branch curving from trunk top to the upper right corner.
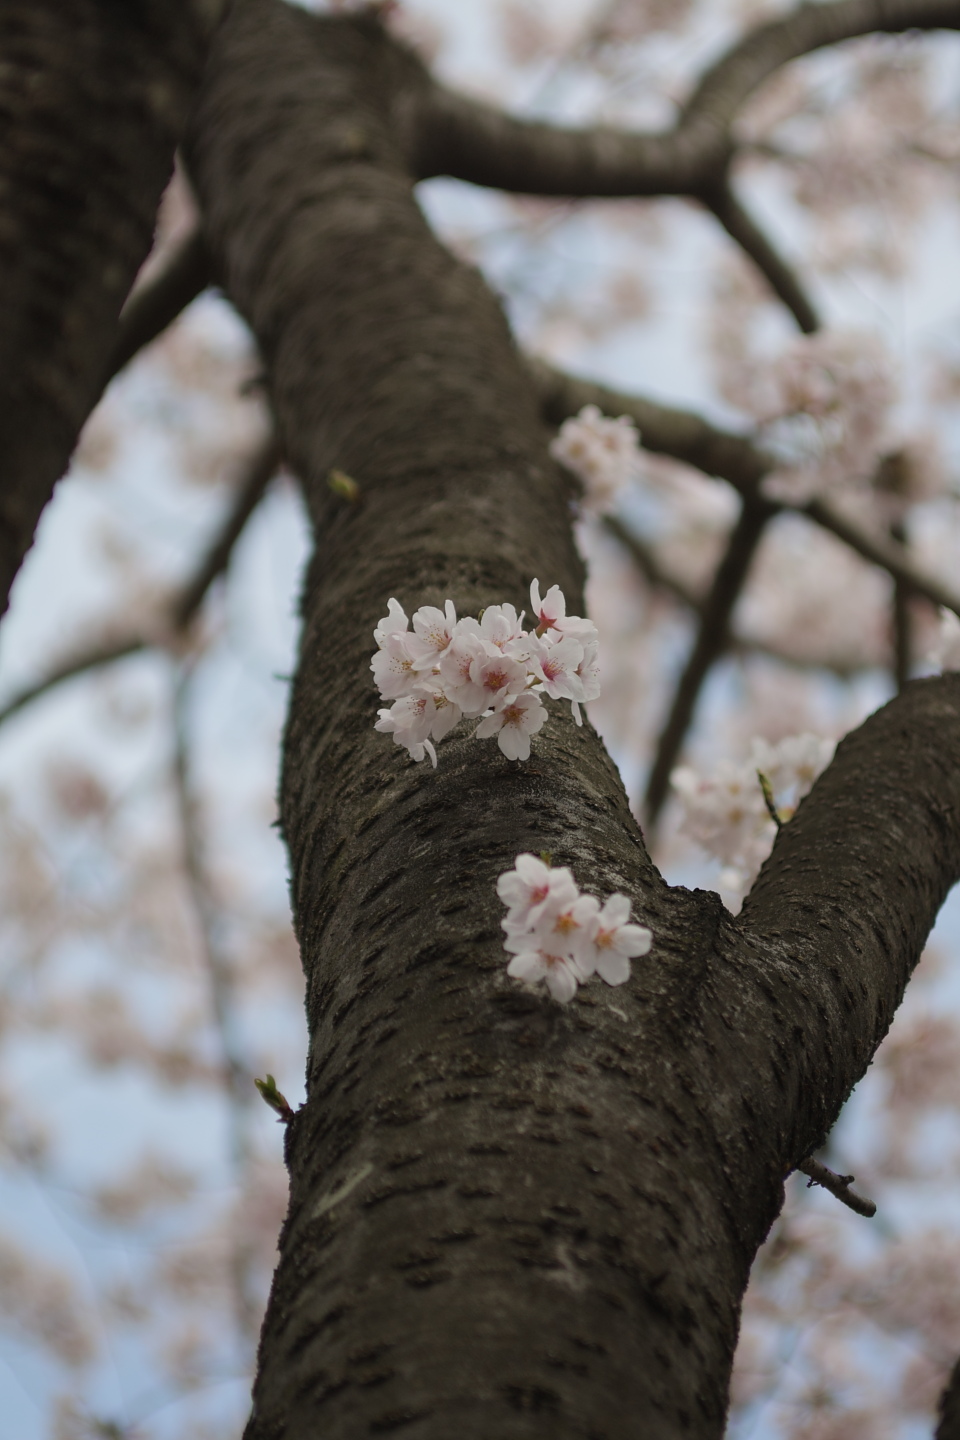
[415,0,960,196]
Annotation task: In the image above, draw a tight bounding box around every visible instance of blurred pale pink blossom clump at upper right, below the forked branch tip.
[757,330,895,503]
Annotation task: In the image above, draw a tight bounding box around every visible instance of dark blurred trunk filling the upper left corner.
[0,0,220,613]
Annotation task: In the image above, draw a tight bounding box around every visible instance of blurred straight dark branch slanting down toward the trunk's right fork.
[643,495,776,827]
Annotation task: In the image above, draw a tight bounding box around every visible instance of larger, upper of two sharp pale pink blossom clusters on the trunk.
[370,580,600,766]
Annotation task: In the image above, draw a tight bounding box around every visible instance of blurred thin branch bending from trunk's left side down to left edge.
[0,433,279,724]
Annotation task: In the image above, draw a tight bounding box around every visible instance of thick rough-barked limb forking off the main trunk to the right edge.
[740,674,960,1165]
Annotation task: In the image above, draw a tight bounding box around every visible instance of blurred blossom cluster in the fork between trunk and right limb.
[671,734,835,891]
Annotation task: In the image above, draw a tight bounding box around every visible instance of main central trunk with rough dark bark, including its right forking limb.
[178,0,960,1440]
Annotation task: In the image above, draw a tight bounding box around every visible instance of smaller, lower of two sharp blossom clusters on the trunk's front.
[497,855,652,1005]
